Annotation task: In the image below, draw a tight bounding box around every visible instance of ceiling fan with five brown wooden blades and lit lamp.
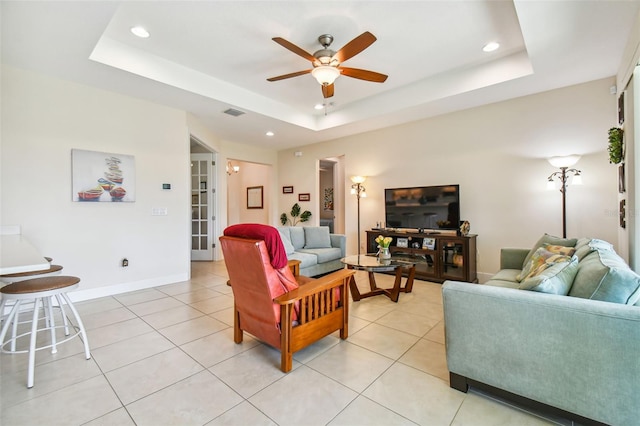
[267,31,387,98]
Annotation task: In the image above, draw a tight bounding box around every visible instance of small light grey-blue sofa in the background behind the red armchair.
[278,226,347,277]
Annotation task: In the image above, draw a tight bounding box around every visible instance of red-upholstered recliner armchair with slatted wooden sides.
[220,224,354,373]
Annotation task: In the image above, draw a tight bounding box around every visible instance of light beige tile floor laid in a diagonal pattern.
[0,262,570,426]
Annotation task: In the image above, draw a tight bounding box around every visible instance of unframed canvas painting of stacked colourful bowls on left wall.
[71,149,136,203]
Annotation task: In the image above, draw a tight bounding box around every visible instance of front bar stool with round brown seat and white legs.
[0,275,91,388]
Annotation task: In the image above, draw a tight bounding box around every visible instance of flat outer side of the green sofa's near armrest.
[442,281,640,424]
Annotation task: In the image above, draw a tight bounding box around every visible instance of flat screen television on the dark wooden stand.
[384,185,460,230]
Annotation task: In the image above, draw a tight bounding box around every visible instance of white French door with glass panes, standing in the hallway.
[191,137,217,261]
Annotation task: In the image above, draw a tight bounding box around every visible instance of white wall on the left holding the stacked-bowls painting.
[0,67,190,298]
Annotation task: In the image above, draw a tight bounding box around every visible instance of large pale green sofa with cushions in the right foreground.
[442,235,640,425]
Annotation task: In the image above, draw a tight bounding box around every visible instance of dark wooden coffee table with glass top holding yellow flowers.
[340,254,416,302]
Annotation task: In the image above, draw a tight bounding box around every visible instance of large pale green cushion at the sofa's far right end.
[569,249,640,305]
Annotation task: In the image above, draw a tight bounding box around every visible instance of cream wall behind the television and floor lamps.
[279,78,618,277]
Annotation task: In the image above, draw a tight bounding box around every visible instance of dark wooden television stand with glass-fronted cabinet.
[366,229,478,283]
